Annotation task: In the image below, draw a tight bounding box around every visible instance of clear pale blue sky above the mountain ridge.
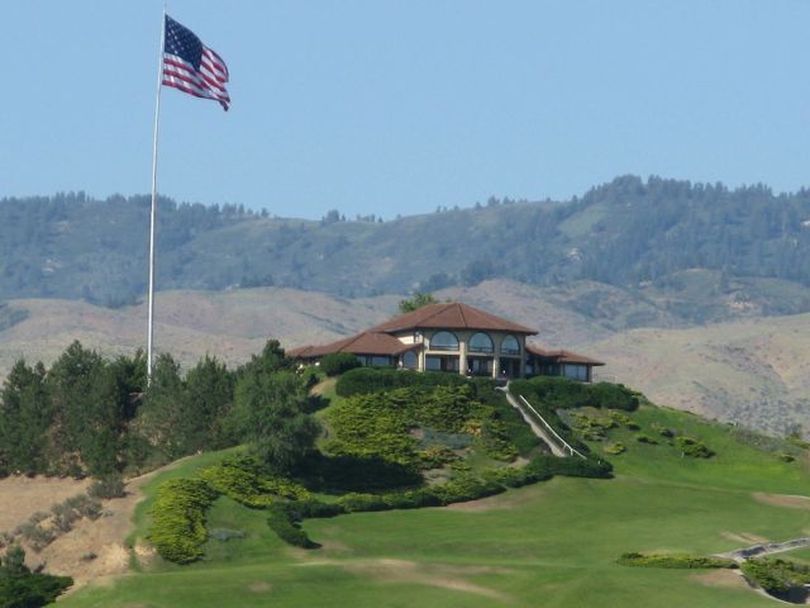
[0,0,810,218]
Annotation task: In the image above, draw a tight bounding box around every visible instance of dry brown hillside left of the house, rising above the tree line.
[0,288,398,374]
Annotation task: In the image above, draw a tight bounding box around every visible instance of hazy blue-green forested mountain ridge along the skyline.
[0,176,810,327]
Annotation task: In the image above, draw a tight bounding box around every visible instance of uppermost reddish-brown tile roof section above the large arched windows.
[369,302,537,335]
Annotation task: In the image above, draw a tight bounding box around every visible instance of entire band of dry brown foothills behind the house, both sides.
[0,280,810,432]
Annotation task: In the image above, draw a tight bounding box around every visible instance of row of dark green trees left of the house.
[0,340,318,477]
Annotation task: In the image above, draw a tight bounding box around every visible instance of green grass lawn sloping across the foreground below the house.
[60,407,810,608]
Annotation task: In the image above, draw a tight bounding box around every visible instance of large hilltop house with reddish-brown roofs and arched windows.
[288,302,604,382]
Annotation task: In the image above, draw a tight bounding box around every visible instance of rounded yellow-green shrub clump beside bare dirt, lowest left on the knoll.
[149,479,218,564]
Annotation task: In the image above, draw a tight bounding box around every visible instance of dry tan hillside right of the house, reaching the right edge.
[588,314,810,432]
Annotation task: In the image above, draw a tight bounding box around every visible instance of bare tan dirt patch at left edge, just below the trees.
[0,476,90,531]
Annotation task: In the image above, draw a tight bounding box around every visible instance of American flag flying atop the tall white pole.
[163,15,231,112]
